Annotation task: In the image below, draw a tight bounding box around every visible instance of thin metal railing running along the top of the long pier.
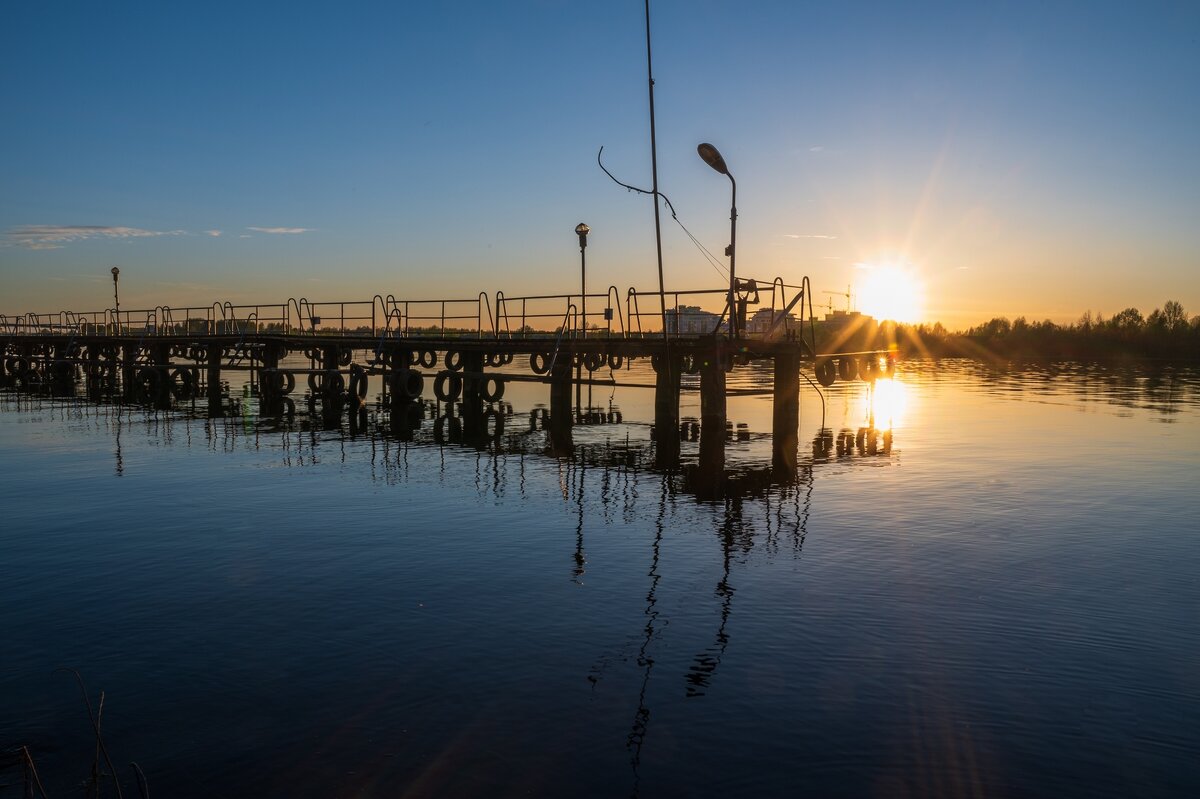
[0,277,812,341]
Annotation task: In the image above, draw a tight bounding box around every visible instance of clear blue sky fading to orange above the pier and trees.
[0,0,1200,324]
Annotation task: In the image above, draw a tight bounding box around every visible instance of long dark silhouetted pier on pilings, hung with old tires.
[0,286,894,484]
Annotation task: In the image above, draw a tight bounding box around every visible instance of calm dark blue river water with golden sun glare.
[0,361,1200,798]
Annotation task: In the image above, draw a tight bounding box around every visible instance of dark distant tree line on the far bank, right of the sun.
[877,300,1200,359]
